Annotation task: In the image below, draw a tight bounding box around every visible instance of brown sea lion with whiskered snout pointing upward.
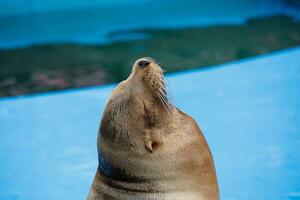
[87,57,219,200]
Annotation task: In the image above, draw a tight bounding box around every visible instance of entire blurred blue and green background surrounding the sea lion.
[0,0,300,200]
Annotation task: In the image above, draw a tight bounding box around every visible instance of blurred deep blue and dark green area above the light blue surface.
[0,0,300,97]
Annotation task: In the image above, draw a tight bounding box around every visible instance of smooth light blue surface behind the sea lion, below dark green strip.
[0,47,300,200]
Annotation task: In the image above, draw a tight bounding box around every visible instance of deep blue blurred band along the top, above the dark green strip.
[0,0,300,49]
